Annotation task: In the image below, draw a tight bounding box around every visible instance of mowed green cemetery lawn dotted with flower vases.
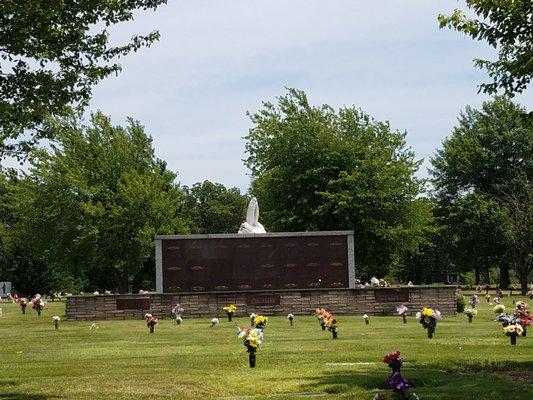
[0,296,533,400]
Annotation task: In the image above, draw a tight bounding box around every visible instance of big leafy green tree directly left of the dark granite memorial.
[7,113,186,292]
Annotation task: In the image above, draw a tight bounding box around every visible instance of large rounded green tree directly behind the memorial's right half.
[245,89,424,276]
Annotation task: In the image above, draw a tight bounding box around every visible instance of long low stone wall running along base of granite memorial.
[66,286,456,320]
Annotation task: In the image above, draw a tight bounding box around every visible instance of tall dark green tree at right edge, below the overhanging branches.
[432,97,533,293]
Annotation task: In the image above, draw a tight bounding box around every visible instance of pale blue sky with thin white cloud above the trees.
[90,0,533,192]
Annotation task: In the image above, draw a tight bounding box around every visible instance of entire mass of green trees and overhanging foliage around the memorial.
[0,0,533,293]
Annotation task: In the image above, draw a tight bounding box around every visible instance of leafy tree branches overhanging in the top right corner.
[438,0,533,96]
